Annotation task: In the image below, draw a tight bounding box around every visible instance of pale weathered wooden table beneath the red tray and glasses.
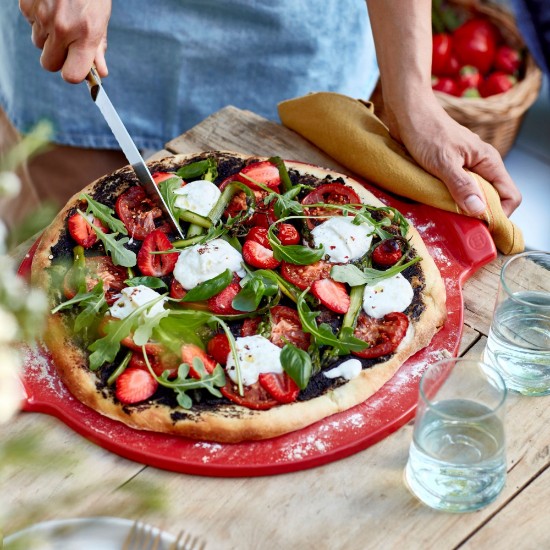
[0,107,550,550]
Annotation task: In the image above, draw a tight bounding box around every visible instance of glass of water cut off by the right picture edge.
[484,252,550,395]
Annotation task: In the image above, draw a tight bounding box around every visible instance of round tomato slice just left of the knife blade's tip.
[115,185,170,241]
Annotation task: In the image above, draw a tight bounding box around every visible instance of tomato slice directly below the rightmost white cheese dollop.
[352,311,409,359]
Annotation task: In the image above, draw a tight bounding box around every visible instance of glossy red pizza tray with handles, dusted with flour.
[20,185,496,477]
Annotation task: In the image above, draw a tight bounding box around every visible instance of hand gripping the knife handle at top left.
[19,0,111,84]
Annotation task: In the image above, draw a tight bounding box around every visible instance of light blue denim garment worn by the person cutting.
[0,0,378,149]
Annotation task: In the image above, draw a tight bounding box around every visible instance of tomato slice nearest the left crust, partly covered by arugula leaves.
[63,256,128,305]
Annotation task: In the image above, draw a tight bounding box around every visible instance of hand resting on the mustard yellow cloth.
[387,90,521,216]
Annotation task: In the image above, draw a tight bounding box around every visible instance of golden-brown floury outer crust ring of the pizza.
[32,152,446,443]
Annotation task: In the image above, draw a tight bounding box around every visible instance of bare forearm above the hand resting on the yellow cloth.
[367,0,438,116]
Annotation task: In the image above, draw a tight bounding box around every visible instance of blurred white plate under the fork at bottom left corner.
[4,517,175,550]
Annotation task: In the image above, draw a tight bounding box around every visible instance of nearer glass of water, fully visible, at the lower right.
[405,358,506,512]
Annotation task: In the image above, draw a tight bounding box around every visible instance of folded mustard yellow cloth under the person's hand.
[279,92,524,254]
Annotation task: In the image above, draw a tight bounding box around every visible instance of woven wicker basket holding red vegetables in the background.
[435,0,542,157]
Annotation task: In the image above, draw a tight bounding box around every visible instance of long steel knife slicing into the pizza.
[86,67,185,239]
